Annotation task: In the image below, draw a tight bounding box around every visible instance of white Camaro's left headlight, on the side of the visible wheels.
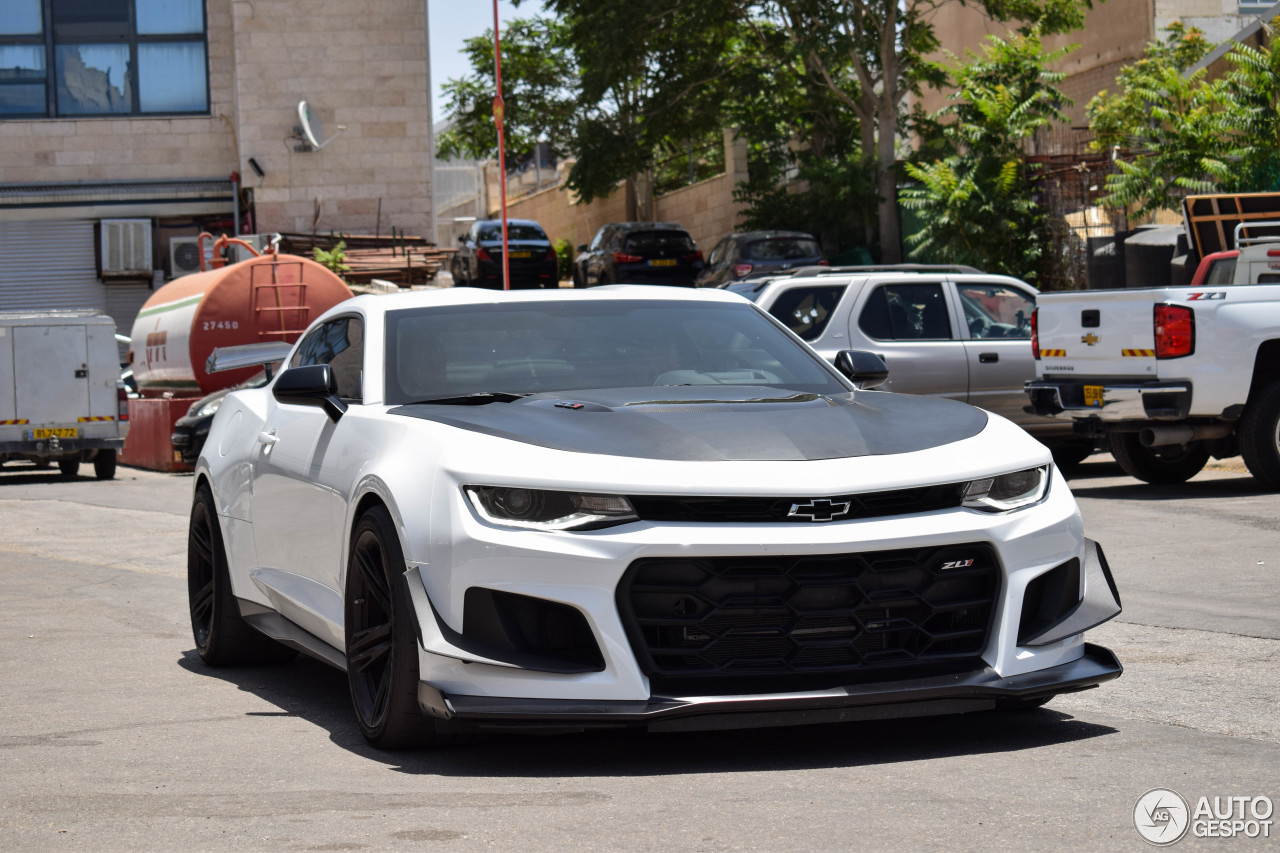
[463,485,639,530]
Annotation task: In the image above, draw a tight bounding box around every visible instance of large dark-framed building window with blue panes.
[0,0,209,119]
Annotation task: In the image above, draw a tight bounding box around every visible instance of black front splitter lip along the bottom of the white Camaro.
[419,643,1124,731]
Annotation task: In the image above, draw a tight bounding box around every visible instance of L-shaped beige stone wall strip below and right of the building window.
[0,0,244,183]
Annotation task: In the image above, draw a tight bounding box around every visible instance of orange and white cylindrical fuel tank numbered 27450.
[132,255,352,397]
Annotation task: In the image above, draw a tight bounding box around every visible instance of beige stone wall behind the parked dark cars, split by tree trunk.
[490,131,746,255]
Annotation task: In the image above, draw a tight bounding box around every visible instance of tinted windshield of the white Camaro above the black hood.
[385,300,849,405]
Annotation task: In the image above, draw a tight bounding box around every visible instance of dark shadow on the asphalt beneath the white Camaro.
[178,651,1117,779]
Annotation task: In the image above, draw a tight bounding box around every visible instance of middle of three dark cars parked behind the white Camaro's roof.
[573,222,703,287]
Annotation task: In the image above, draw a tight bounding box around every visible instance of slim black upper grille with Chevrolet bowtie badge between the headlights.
[630,483,964,524]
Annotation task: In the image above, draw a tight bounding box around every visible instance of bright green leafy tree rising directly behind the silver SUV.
[902,28,1074,283]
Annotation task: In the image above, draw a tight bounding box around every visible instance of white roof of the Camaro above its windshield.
[321,284,746,319]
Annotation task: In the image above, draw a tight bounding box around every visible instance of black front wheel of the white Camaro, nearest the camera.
[344,506,439,749]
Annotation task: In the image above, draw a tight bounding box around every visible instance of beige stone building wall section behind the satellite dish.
[234,0,433,237]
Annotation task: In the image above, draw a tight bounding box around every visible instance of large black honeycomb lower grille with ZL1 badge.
[617,543,1001,692]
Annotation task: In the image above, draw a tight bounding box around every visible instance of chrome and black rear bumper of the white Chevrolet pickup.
[1023,379,1192,421]
